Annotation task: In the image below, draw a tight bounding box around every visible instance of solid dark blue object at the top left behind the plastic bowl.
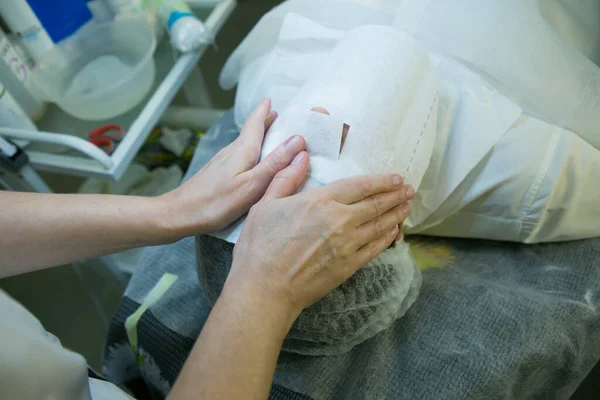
[27,0,92,43]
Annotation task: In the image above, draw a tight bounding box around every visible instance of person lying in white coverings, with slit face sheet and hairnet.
[197,1,600,355]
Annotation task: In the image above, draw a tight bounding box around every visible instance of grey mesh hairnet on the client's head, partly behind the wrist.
[196,236,421,356]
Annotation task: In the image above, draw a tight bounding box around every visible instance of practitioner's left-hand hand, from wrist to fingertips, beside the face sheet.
[162,99,306,235]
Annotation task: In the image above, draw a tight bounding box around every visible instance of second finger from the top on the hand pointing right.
[350,185,416,226]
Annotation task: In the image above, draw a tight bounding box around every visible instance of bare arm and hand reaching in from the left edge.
[0,99,306,278]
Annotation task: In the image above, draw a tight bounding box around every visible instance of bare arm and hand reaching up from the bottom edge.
[168,148,414,400]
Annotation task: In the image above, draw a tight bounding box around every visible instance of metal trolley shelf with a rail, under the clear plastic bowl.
[0,0,236,180]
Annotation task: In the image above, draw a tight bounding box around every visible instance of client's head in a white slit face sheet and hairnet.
[196,26,437,355]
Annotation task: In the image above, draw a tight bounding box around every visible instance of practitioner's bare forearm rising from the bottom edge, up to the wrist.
[169,284,298,400]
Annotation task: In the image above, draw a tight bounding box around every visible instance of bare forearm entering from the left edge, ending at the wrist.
[0,191,181,277]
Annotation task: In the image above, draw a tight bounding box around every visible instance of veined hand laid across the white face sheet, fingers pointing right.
[224,152,414,325]
